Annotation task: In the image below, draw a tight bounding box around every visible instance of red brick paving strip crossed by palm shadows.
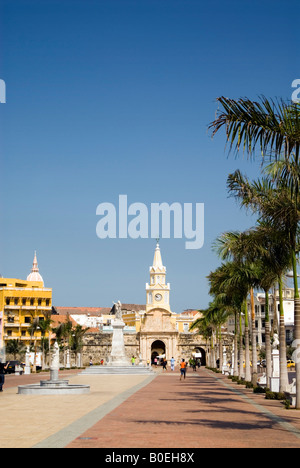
[68,369,300,448]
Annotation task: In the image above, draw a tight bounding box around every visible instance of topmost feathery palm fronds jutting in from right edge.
[209,96,300,164]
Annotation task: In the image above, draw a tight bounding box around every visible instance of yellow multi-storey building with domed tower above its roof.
[0,253,52,348]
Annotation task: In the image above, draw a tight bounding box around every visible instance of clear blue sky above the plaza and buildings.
[0,0,300,312]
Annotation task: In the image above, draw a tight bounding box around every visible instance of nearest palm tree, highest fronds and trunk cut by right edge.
[209,96,300,409]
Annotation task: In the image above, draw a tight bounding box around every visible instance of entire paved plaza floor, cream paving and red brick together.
[0,369,300,449]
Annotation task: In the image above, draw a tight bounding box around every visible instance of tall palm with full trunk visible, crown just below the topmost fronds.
[228,171,299,391]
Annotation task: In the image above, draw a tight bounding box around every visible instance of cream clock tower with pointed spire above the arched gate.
[146,240,171,313]
